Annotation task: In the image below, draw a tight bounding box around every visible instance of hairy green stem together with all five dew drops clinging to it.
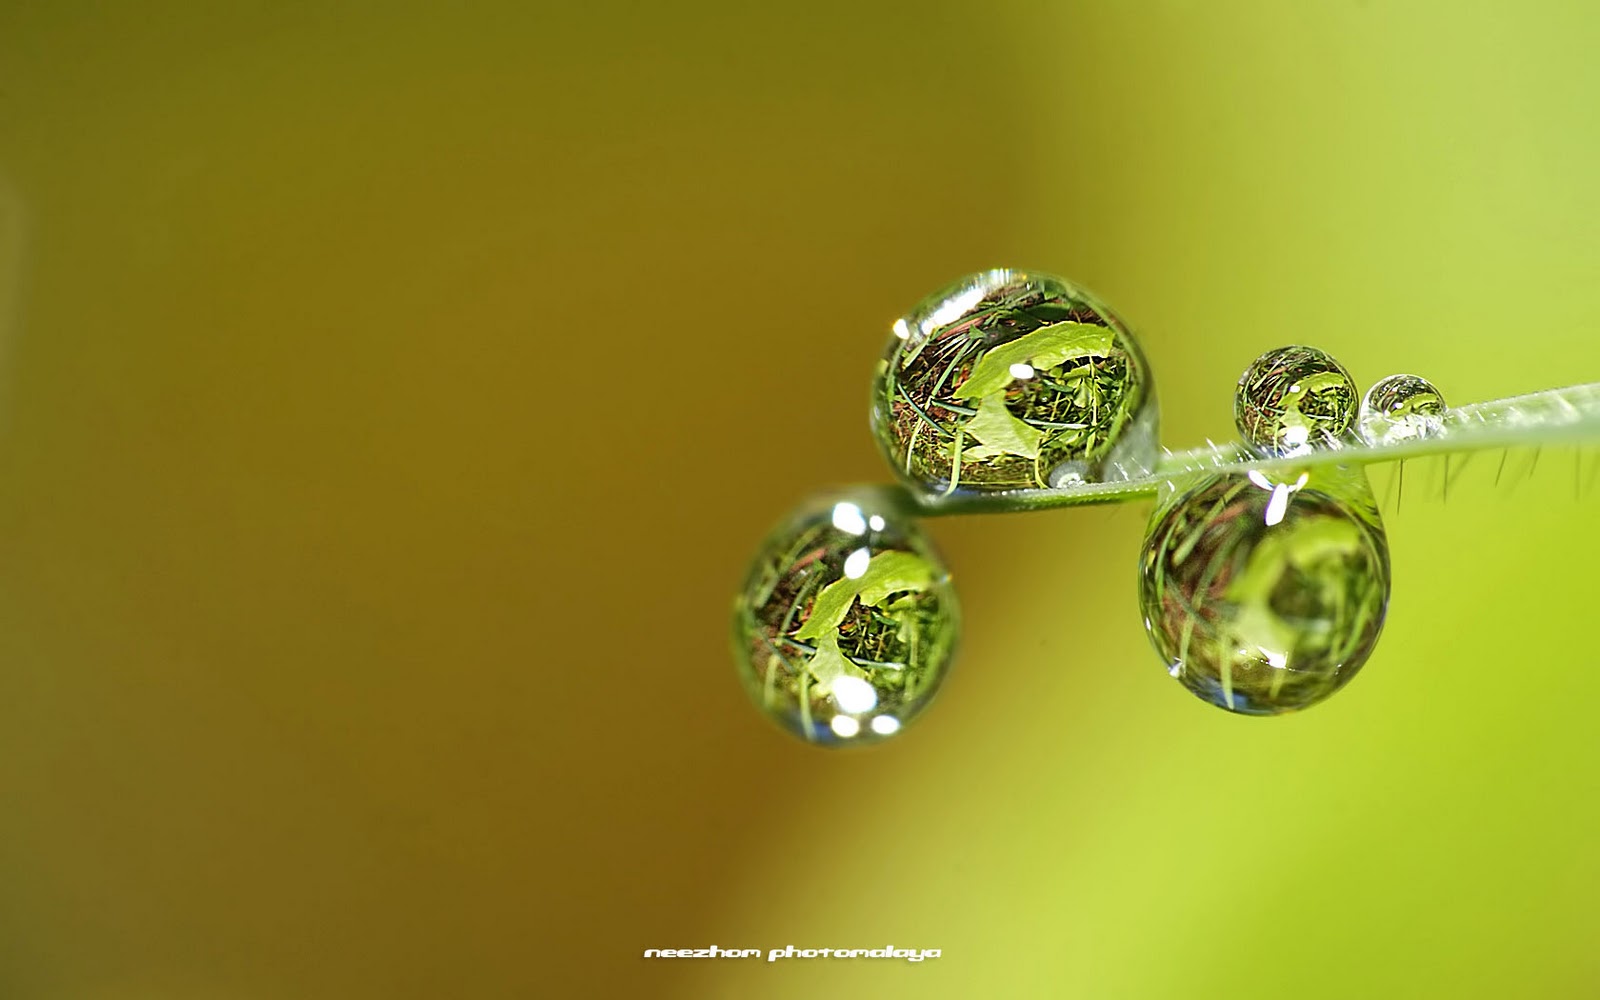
[733,269,1600,747]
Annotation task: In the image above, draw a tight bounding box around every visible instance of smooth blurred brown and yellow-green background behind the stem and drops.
[0,2,1600,1000]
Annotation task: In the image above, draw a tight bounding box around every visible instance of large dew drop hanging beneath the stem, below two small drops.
[1139,467,1389,715]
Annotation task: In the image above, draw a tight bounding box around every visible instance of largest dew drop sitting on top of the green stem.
[872,270,1158,494]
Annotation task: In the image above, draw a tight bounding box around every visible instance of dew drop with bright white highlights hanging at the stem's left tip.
[733,488,960,747]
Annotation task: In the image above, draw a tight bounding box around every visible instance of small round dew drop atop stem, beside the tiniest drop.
[1234,346,1358,456]
